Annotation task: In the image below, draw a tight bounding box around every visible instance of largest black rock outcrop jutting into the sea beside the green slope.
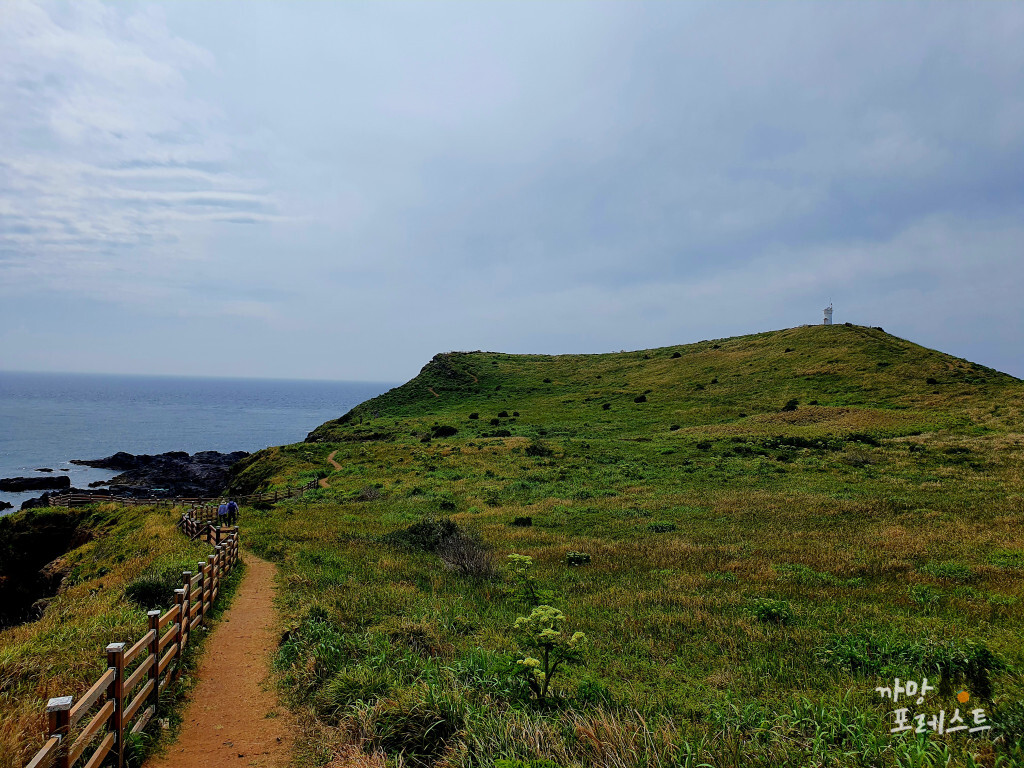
[72,451,249,499]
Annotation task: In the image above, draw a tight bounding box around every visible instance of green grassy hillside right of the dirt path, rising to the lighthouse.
[233,326,1024,768]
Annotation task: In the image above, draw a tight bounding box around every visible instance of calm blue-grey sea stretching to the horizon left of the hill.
[0,372,395,515]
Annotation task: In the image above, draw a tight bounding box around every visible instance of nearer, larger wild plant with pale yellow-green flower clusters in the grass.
[513,605,587,701]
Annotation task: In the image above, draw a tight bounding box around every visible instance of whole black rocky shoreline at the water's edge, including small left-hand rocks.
[6,451,249,509]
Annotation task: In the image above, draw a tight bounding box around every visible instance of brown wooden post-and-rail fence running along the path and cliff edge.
[26,480,303,768]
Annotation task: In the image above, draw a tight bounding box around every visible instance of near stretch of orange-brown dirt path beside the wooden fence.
[145,553,292,768]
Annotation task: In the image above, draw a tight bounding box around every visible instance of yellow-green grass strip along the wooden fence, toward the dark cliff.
[0,504,241,766]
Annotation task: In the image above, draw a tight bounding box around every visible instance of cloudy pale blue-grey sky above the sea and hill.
[0,0,1024,381]
